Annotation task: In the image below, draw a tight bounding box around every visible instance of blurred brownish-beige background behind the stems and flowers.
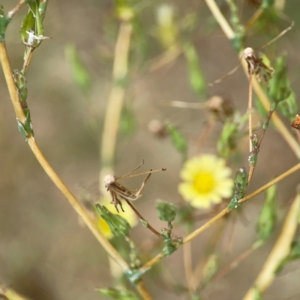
[0,0,300,300]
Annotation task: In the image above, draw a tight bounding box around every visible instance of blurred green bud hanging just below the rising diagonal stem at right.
[256,185,277,242]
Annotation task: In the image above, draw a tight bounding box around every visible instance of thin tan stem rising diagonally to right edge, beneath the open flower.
[142,163,300,268]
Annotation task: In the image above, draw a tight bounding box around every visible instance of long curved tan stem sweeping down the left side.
[0,43,129,271]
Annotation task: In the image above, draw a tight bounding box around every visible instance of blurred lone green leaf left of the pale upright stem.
[65,44,91,92]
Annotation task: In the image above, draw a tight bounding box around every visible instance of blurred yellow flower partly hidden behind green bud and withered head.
[96,196,138,239]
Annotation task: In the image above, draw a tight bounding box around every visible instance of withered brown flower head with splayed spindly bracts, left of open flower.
[103,161,166,212]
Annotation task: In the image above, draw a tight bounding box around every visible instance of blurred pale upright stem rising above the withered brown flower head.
[99,21,132,195]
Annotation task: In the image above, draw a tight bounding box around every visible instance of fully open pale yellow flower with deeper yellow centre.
[178,154,233,208]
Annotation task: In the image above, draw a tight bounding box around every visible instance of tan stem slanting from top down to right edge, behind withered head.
[205,0,300,159]
